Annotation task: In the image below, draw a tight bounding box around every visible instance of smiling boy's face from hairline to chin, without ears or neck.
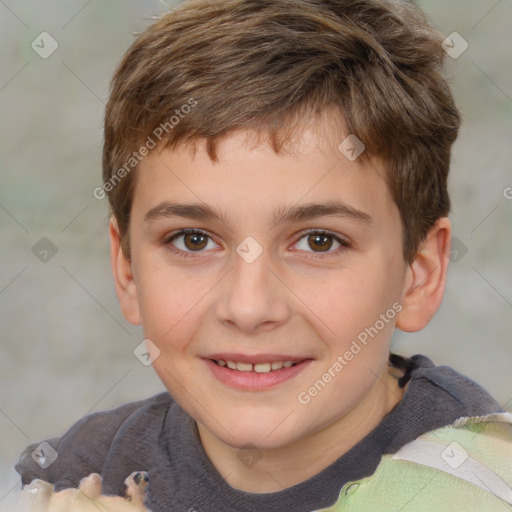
[124,117,408,448]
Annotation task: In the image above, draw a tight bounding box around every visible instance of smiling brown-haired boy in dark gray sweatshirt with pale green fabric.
[16,0,512,512]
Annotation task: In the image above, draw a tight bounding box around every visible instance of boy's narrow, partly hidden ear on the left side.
[109,217,141,325]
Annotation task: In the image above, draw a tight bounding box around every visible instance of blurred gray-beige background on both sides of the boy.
[0,0,512,506]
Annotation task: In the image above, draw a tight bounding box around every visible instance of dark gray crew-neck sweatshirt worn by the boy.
[15,355,503,512]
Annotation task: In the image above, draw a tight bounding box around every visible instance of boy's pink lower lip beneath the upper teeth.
[204,359,312,391]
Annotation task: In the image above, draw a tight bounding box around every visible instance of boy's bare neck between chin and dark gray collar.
[197,369,405,493]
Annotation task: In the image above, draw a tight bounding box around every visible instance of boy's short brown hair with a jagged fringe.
[103,0,460,262]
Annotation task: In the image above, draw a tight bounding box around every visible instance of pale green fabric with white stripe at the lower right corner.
[318,413,512,512]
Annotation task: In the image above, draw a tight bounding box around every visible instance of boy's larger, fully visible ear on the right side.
[396,217,451,332]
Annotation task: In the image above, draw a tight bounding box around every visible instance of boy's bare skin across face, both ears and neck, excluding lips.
[110,118,450,493]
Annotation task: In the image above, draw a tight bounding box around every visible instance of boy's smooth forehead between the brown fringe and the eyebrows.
[133,119,396,230]
